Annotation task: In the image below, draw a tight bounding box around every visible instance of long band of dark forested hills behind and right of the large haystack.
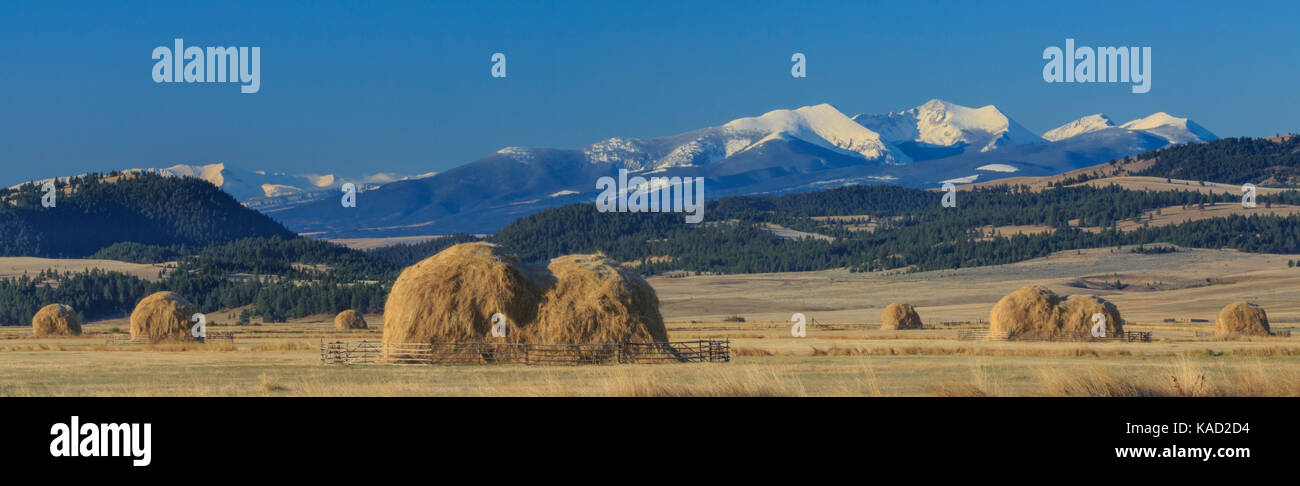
[493,181,1300,274]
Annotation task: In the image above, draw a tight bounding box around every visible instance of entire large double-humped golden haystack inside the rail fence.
[384,242,668,344]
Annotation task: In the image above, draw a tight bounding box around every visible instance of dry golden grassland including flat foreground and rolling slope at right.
[0,248,1300,396]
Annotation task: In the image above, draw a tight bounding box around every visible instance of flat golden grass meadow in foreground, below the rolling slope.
[0,305,1300,396]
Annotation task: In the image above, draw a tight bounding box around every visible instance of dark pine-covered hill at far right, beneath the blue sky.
[1134,135,1300,187]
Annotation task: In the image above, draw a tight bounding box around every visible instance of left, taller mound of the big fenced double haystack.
[384,242,542,343]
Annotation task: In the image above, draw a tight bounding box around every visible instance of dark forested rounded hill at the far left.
[0,173,296,257]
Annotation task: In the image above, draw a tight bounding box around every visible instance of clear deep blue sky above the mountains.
[0,1,1300,183]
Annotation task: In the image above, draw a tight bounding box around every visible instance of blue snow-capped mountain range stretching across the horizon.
[269,99,1217,237]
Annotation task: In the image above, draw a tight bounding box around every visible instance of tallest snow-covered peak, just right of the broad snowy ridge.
[853,99,1043,152]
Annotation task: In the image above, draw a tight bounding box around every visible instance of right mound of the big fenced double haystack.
[525,255,668,344]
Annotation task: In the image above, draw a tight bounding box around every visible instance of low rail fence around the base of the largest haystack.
[321,339,731,365]
